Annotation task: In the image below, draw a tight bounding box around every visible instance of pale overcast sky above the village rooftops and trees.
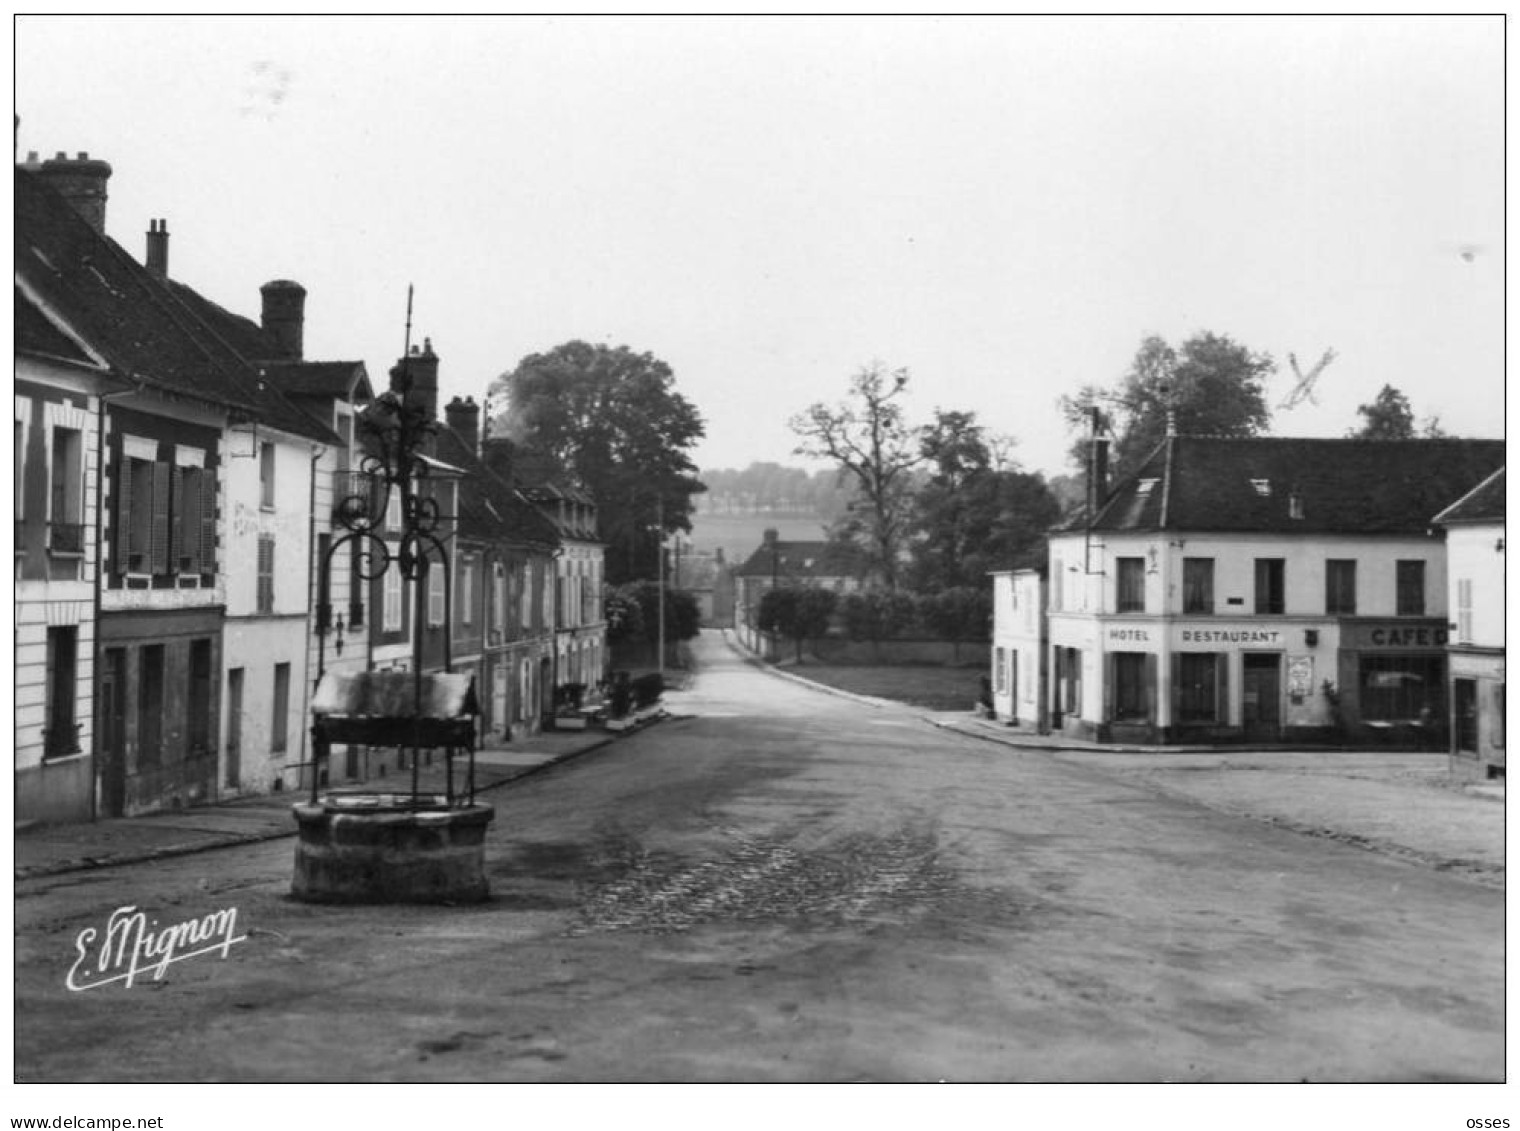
[15,17,1503,473]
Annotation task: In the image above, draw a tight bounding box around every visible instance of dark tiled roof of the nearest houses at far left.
[14,167,337,442]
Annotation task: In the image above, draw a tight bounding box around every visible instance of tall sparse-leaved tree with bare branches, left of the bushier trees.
[787,362,923,588]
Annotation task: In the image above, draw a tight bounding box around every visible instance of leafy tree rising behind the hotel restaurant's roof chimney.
[1061,331,1277,479]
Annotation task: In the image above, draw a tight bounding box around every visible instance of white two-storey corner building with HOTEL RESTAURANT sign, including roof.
[1049,436,1505,745]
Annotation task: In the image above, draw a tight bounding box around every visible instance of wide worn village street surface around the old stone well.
[15,635,1505,1082]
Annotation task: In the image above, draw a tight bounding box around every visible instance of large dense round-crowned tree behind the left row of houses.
[491,342,705,585]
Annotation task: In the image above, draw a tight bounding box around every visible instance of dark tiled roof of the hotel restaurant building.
[1062,436,1505,534]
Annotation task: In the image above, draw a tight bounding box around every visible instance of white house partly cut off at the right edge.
[1432,468,1505,778]
